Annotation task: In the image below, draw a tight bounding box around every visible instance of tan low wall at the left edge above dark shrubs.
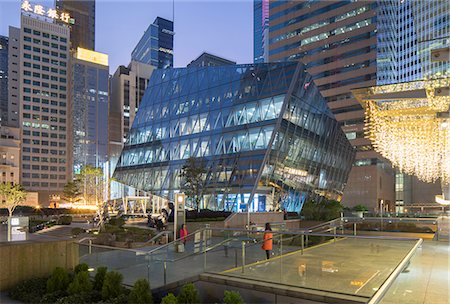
[0,241,78,291]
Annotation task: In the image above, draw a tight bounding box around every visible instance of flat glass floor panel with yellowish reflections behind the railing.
[222,238,416,298]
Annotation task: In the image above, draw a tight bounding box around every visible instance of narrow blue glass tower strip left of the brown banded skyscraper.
[253,0,269,63]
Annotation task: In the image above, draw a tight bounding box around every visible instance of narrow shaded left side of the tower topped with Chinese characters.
[7,26,21,128]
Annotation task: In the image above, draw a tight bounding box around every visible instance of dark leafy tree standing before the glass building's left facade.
[180,157,206,211]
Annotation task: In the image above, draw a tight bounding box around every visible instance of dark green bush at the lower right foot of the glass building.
[301,200,343,221]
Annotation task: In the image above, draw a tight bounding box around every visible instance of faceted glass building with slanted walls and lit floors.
[114,62,354,211]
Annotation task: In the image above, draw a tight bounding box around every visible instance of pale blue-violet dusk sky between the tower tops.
[0,0,253,74]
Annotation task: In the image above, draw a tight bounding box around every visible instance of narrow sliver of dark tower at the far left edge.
[0,36,8,126]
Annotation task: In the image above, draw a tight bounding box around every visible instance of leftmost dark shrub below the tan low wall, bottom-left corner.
[8,278,47,303]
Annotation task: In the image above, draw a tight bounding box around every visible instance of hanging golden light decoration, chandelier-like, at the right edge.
[353,78,450,204]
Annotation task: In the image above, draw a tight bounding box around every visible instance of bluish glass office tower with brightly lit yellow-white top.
[69,47,109,174]
